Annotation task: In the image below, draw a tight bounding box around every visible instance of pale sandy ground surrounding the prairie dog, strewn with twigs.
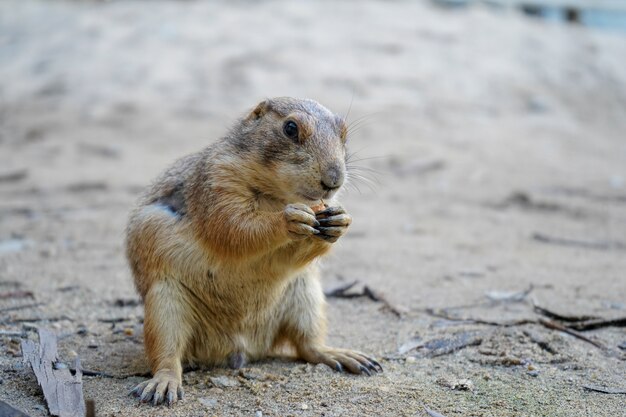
[0,0,626,417]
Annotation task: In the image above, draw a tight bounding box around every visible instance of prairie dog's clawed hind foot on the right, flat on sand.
[300,347,383,376]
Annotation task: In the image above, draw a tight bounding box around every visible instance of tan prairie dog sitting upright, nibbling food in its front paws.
[126,97,382,405]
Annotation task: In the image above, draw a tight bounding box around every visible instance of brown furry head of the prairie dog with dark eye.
[235,97,347,204]
